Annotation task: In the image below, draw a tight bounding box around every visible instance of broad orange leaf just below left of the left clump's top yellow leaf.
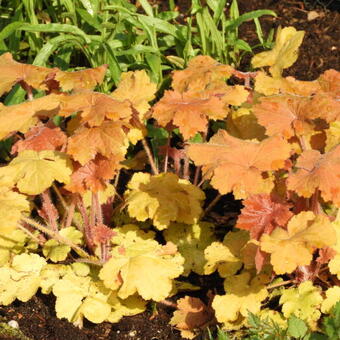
[59,91,132,126]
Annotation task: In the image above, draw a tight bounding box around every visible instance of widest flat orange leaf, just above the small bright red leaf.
[188,130,290,199]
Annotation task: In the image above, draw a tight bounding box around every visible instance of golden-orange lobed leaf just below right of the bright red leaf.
[260,211,336,274]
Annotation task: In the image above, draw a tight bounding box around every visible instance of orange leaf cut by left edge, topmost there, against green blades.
[0,53,55,96]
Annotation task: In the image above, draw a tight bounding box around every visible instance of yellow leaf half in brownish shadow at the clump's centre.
[125,172,205,230]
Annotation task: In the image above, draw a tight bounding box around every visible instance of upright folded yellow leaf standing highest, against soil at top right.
[251,27,305,78]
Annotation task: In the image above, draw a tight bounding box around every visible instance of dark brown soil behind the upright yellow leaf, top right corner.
[238,0,340,80]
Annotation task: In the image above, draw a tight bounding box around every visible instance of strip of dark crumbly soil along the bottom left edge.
[0,294,182,340]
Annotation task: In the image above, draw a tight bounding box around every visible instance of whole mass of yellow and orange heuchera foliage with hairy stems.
[0,28,340,338]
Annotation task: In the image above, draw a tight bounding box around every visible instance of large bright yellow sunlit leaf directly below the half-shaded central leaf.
[99,226,184,301]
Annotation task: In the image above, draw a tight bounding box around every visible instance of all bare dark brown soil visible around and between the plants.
[0,0,340,340]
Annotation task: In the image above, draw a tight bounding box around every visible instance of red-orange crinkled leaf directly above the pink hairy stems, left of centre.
[65,155,120,194]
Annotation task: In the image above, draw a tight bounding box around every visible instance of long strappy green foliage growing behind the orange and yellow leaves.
[0,0,275,92]
